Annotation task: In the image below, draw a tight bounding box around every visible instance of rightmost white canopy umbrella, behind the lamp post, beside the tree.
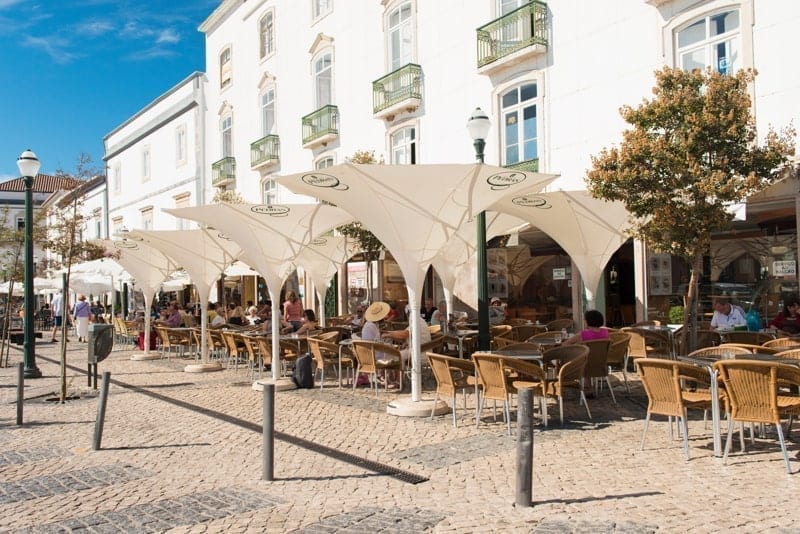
[492,191,628,307]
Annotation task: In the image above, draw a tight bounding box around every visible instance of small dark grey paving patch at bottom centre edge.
[294,507,445,534]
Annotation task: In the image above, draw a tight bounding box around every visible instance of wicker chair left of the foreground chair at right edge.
[636,358,712,460]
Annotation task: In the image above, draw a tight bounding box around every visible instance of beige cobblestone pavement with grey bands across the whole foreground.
[0,343,800,533]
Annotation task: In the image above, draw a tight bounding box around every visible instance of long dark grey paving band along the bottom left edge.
[20,488,282,533]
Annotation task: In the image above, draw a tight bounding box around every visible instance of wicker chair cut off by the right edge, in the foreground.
[714,360,800,474]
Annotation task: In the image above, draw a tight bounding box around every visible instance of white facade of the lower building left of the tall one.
[103,72,207,235]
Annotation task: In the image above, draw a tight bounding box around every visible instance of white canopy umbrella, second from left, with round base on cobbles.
[128,227,242,372]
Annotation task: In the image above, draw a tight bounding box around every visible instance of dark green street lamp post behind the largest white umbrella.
[467,108,492,351]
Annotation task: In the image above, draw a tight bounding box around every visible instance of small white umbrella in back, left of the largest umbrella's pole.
[295,235,358,326]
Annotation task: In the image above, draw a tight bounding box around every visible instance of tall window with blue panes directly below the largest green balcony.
[500,83,539,165]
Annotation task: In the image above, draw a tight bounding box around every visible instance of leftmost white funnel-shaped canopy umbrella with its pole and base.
[95,237,178,360]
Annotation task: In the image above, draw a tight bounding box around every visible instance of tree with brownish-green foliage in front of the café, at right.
[587,68,795,348]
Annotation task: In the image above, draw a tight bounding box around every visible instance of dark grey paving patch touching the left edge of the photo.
[0,465,149,505]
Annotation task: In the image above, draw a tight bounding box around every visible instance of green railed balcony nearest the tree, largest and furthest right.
[478,0,547,68]
